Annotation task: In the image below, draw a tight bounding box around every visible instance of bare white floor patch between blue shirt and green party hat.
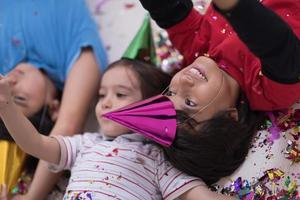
[87,0,146,62]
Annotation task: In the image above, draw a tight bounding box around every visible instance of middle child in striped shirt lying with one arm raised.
[0,59,233,200]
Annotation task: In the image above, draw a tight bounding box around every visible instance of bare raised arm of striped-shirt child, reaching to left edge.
[0,77,60,163]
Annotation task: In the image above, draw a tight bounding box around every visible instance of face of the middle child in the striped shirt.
[96,66,142,137]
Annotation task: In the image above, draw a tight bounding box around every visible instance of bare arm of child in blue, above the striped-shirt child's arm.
[51,50,100,135]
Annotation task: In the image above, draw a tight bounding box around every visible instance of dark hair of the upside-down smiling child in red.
[163,94,264,185]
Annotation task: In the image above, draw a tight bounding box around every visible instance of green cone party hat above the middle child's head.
[122,15,156,64]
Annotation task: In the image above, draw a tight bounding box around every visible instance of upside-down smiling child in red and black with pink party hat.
[106,0,300,188]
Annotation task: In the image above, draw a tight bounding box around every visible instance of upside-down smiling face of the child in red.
[167,56,239,122]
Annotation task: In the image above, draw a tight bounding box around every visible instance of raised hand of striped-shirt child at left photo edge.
[0,75,12,109]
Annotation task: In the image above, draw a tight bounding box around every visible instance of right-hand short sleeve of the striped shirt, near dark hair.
[157,156,205,200]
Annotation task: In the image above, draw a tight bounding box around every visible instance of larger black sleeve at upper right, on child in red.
[214,0,300,84]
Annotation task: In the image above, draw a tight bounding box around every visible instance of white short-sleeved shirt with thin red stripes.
[49,133,204,200]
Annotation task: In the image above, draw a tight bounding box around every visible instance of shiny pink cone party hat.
[103,95,176,147]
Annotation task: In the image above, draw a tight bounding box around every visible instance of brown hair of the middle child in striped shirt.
[103,58,171,99]
